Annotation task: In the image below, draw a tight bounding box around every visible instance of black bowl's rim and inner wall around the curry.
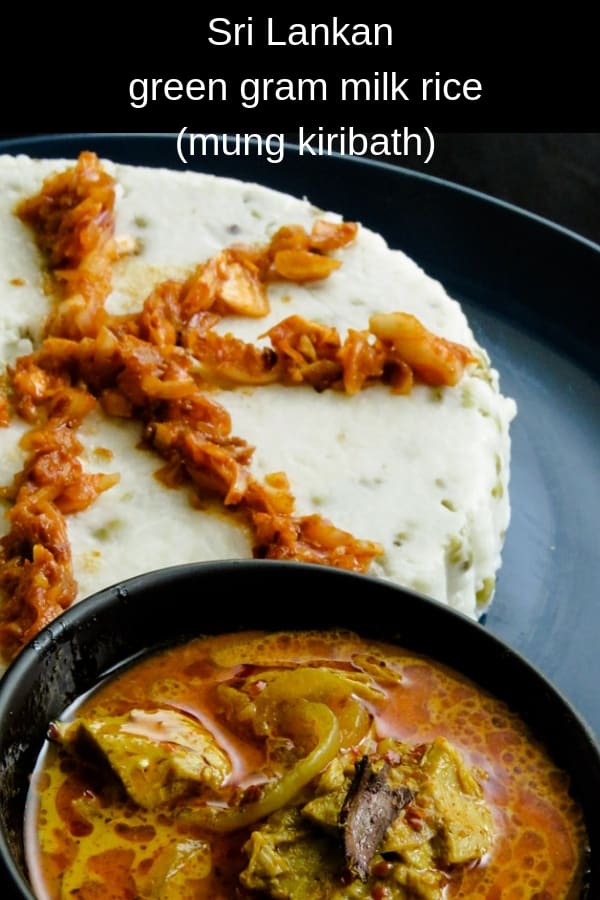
[0,560,600,900]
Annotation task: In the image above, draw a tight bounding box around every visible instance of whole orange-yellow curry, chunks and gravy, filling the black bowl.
[27,632,586,900]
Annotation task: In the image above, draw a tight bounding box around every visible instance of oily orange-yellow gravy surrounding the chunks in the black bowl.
[26,632,586,900]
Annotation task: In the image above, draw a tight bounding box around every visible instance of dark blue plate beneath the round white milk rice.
[0,134,600,734]
